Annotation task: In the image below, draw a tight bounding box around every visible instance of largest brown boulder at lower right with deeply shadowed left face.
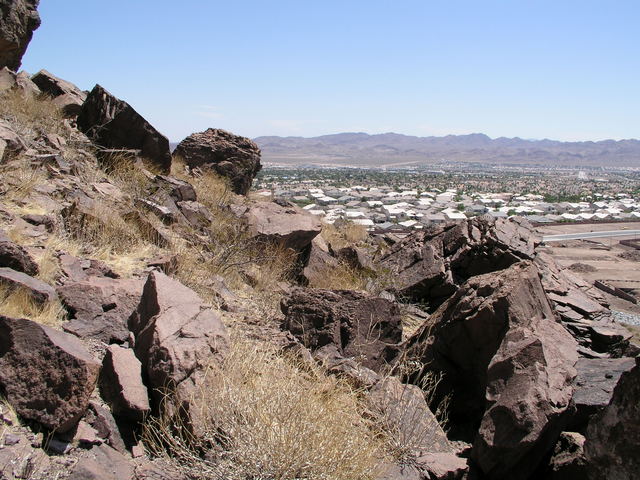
[407,262,578,479]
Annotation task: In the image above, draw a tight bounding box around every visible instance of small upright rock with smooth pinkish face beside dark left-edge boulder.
[100,345,151,420]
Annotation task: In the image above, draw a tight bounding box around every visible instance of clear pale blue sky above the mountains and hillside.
[23,0,640,140]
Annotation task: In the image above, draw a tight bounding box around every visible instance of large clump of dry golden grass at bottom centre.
[144,341,384,480]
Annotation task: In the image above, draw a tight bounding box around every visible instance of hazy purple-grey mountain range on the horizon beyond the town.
[254,133,640,167]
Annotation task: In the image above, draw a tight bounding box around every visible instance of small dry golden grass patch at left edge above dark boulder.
[0,284,66,327]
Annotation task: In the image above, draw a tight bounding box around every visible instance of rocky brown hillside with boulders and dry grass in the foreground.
[0,2,640,480]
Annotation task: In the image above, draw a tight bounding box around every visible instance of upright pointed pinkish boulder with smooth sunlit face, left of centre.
[129,272,230,409]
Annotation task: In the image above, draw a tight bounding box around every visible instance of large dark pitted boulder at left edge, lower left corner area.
[0,316,100,432]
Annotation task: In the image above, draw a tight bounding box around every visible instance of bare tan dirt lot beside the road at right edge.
[537,222,640,314]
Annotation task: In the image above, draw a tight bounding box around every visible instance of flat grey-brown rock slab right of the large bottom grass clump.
[368,377,452,456]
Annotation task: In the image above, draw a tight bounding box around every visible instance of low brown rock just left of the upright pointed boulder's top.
[57,277,144,344]
